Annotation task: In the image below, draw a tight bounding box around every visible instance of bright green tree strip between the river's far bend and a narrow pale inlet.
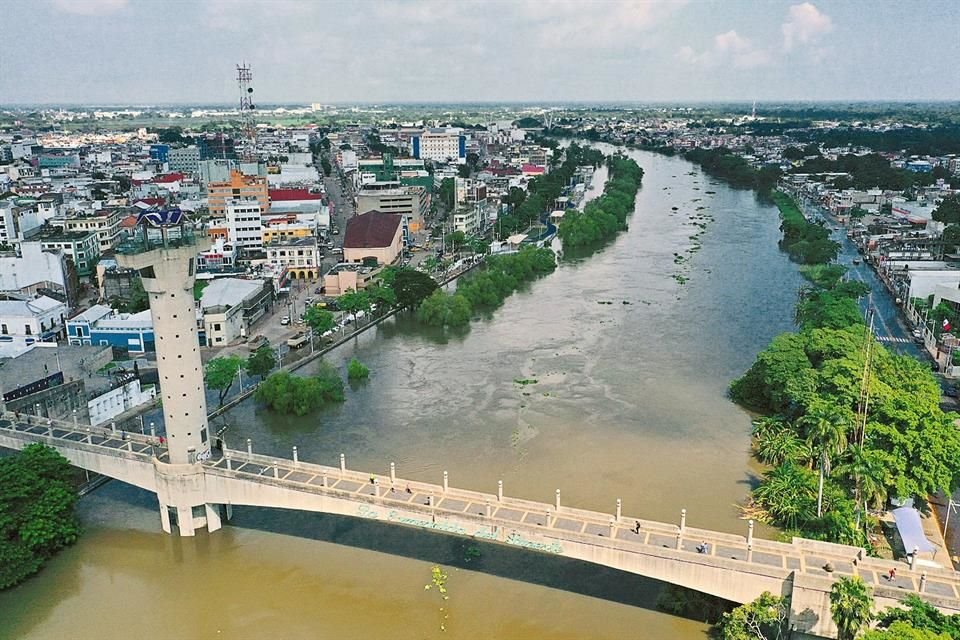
[558,155,643,248]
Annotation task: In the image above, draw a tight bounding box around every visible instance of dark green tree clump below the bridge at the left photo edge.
[0,444,80,589]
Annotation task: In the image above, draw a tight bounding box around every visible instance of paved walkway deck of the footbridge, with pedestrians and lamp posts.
[0,419,960,600]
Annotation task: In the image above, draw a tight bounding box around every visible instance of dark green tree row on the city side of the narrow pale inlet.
[496,140,604,238]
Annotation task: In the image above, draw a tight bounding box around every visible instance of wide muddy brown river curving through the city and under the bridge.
[0,145,801,640]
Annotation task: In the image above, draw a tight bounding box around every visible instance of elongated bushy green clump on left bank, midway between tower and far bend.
[417,247,557,327]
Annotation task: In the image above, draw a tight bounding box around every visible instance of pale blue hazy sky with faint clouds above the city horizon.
[0,0,960,104]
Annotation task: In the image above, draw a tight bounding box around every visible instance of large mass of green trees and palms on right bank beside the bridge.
[731,236,960,546]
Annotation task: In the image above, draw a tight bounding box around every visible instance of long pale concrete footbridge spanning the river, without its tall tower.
[0,414,960,637]
